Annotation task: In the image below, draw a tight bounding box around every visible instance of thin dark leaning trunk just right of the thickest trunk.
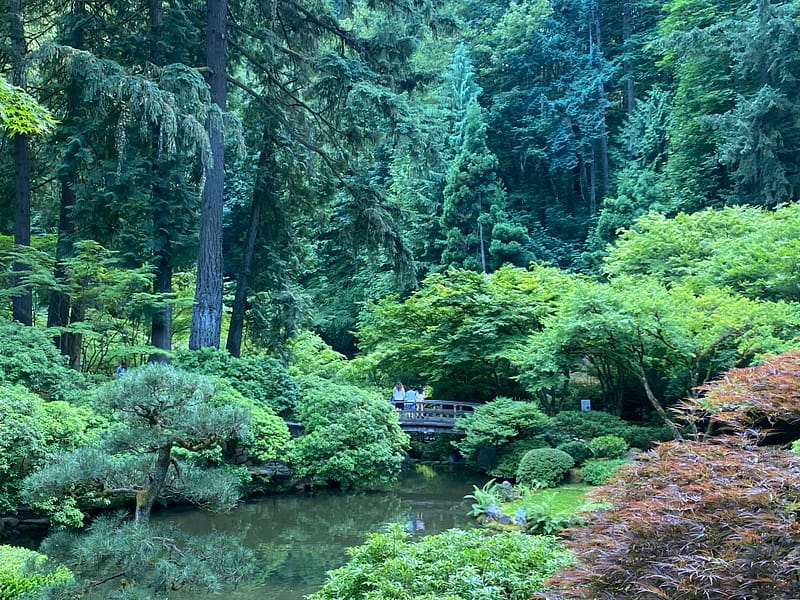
[226,127,272,357]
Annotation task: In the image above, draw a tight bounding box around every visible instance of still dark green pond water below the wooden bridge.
[153,466,486,600]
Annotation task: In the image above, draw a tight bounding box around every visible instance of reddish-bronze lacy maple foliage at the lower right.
[557,353,800,599]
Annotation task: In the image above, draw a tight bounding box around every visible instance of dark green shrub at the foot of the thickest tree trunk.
[172,348,298,418]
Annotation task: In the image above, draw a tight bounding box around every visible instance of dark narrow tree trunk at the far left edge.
[11,0,33,325]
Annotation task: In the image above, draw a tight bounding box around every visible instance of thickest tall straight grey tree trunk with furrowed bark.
[189,0,228,350]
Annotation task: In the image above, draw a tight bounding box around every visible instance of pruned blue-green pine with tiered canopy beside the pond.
[25,363,250,526]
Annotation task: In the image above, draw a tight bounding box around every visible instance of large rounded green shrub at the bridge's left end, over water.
[289,377,408,489]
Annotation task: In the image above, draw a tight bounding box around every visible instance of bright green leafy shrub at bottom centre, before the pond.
[308,526,572,600]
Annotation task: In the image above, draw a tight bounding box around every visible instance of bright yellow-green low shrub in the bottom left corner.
[0,546,72,600]
